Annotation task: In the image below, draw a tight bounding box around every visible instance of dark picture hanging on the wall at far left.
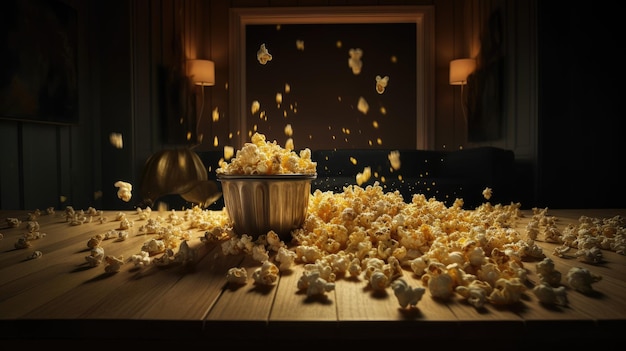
[0,0,79,124]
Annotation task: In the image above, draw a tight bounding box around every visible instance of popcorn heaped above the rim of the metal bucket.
[215,132,317,175]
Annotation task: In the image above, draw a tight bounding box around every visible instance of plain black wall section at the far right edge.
[538,1,626,208]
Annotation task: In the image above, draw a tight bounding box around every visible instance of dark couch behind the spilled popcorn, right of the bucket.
[311,147,515,209]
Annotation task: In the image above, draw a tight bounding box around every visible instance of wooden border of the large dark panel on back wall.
[229,6,434,149]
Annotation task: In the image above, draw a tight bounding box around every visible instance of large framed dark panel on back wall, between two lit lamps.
[229,6,434,149]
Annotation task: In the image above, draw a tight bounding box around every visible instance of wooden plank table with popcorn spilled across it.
[0,209,626,349]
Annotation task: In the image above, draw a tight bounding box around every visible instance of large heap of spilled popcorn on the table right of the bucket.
[214,183,626,308]
